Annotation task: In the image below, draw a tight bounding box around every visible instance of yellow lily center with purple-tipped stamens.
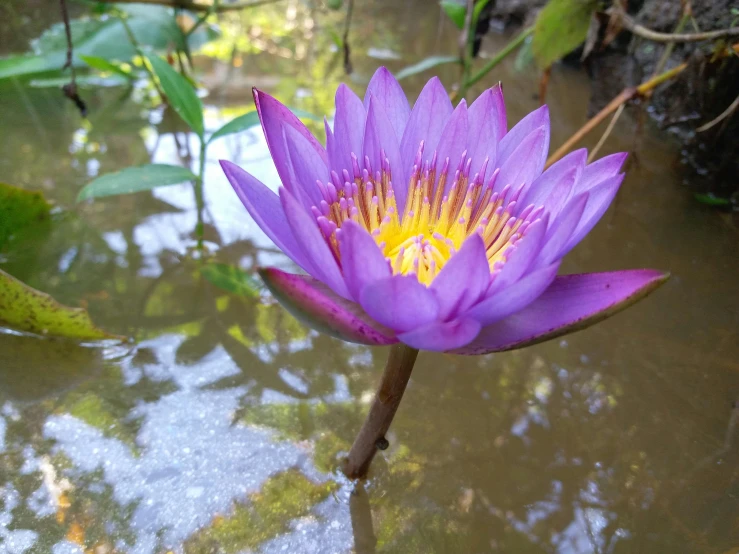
[312,142,544,285]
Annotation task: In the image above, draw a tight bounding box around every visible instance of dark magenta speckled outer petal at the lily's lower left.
[259,268,398,345]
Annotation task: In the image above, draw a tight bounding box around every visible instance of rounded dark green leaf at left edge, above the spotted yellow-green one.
[0,183,50,250]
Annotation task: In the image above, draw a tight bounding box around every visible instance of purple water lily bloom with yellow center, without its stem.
[222,68,666,354]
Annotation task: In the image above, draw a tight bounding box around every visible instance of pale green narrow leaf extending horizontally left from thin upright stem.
[77,164,197,202]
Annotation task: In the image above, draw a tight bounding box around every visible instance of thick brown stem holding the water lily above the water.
[343,344,418,479]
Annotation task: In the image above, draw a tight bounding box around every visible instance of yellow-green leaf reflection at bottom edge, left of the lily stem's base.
[185,469,337,554]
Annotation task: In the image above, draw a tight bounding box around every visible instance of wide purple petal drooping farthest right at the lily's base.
[455,269,669,354]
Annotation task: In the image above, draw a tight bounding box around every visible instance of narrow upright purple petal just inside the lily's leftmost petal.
[280,188,349,298]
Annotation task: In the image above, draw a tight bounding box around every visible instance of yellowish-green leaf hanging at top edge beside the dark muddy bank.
[533,0,598,69]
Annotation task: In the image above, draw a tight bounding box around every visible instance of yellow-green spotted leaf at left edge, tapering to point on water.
[0,269,122,341]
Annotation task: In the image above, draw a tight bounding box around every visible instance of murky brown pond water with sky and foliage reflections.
[0,0,739,554]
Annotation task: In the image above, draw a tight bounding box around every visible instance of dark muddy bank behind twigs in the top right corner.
[492,0,739,203]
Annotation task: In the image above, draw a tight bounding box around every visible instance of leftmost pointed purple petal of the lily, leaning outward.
[221,160,313,273]
